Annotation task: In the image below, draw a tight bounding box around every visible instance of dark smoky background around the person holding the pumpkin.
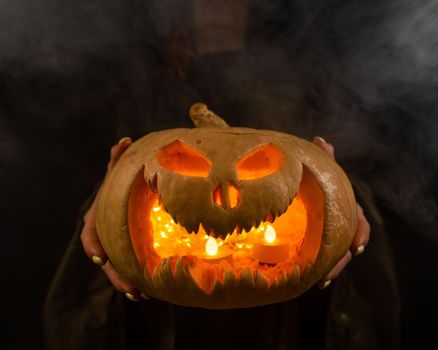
[0,0,438,349]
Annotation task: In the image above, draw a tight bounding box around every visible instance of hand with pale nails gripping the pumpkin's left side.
[81,137,140,301]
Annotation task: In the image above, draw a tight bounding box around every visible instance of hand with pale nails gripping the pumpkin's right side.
[313,136,370,289]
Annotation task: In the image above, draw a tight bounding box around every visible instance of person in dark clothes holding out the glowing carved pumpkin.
[44,0,398,350]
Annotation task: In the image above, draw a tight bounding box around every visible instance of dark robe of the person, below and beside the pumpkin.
[44,181,400,350]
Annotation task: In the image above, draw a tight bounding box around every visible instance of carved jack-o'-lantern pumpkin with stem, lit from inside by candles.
[97,104,357,309]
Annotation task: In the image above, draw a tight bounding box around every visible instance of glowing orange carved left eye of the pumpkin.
[157,140,211,177]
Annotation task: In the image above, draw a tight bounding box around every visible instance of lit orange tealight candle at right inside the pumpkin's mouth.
[252,225,289,264]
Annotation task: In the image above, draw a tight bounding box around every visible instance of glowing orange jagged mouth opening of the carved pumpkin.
[128,167,324,293]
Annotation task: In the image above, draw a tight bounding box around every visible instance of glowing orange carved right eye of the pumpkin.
[236,144,284,180]
